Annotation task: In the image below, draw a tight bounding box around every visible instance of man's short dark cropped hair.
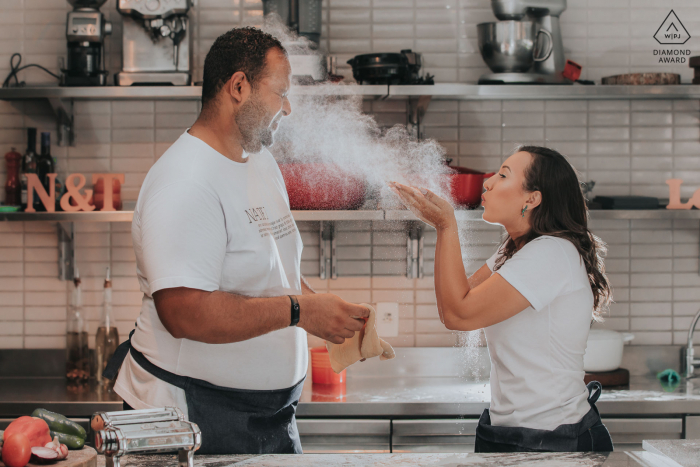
[202,27,286,106]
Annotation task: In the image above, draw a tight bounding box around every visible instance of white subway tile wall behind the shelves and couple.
[0,0,700,348]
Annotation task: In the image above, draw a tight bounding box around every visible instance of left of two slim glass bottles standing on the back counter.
[66,268,90,384]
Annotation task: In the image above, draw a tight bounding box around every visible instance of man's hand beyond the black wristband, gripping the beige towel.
[297,294,369,344]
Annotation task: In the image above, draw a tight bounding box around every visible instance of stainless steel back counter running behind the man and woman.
[0,375,700,418]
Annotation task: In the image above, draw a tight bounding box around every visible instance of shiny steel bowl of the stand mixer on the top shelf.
[476,21,537,73]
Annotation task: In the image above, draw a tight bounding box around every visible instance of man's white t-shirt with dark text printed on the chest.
[115,132,307,413]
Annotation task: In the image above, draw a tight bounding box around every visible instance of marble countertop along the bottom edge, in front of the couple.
[97,451,653,467]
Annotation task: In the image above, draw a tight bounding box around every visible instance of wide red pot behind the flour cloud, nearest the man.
[280,164,365,210]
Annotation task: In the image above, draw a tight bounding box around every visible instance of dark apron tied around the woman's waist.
[475,381,613,452]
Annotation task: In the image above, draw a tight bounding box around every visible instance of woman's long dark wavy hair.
[494,146,612,320]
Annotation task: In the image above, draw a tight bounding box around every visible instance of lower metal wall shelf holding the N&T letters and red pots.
[0,209,700,222]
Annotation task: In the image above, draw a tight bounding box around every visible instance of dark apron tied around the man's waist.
[103,331,304,454]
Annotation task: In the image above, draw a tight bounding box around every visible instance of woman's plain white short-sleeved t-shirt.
[484,236,593,430]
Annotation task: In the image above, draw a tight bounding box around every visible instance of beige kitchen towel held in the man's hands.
[326,303,396,373]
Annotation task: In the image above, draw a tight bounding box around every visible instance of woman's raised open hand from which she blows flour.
[388,182,457,229]
